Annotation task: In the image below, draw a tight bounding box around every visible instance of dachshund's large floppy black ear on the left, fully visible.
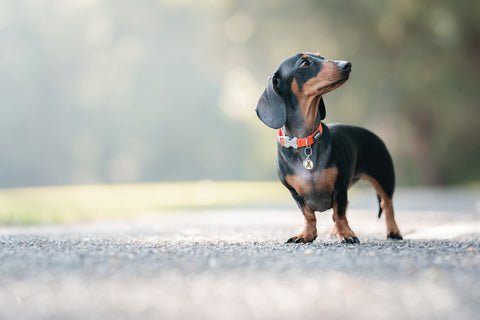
[255,77,287,129]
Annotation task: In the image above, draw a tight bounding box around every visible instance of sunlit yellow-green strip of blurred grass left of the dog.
[0,180,291,225]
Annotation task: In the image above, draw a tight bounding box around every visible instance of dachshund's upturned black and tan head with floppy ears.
[256,53,352,129]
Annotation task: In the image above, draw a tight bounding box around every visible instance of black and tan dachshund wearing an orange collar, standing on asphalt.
[256,53,402,243]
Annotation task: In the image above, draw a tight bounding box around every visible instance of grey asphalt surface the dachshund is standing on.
[0,190,480,319]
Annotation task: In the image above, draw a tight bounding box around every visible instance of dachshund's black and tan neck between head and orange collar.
[284,96,322,138]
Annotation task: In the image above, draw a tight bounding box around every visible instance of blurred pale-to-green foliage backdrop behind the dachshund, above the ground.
[0,0,480,187]
